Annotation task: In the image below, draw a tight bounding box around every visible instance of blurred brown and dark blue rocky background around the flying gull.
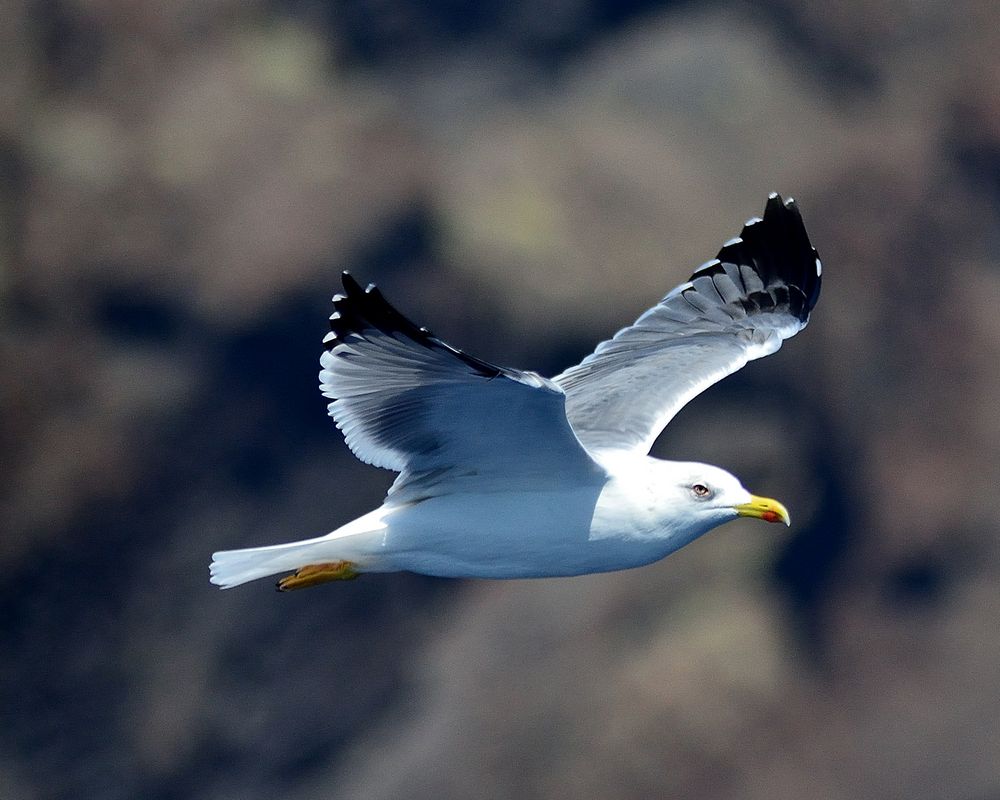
[0,0,1000,800]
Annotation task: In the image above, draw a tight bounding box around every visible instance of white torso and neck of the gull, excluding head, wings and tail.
[376,459,749,578]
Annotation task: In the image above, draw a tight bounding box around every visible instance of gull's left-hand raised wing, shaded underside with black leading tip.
[319,272,597,491]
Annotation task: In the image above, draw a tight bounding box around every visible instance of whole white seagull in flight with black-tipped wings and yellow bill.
[210,194,822,591]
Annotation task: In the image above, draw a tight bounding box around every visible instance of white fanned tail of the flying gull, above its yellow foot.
[209,508,385,589]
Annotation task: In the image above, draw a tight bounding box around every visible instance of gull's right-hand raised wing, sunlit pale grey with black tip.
[553,194,822,453]
